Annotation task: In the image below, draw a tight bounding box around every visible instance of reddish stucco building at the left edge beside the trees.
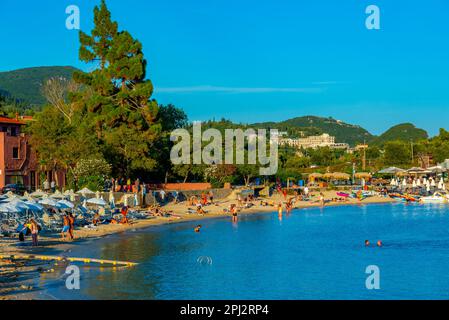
[0,117,65,190]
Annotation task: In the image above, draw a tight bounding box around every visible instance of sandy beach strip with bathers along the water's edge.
[0,191,395,300]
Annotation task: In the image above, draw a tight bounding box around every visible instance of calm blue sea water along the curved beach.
[41,204,449,299]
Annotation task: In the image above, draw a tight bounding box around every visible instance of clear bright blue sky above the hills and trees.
[0,0,449,134]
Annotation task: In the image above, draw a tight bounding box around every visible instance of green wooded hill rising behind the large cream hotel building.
[253,116,375,146]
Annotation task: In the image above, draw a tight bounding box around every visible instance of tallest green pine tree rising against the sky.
[73,0,161,175]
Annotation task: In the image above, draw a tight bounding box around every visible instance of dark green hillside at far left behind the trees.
[0,67,77,106]
